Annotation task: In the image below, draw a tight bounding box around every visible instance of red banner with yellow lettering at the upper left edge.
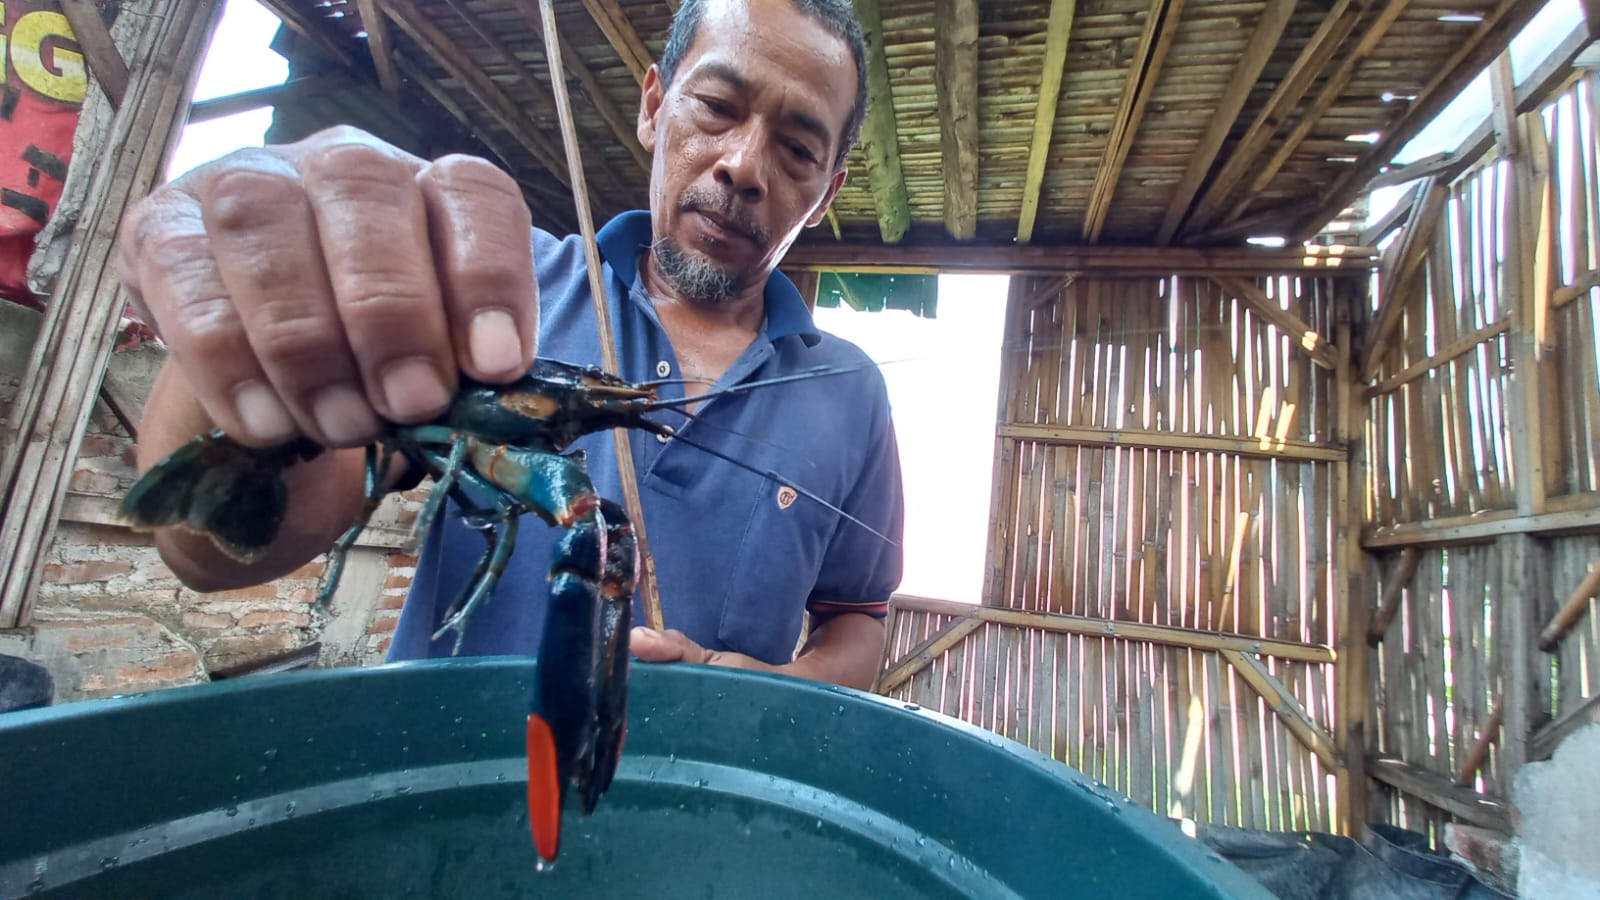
[0,0,88,306]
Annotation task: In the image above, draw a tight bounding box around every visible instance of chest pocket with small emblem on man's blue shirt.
[717,464,838,665]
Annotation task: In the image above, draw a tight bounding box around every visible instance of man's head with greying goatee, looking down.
[638,0,856,303]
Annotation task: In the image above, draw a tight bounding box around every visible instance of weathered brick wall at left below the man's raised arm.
[0,303,426,701]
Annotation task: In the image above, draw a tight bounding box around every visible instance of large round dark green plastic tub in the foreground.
[0,658,1266,900]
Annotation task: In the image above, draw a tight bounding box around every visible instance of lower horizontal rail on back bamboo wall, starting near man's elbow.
[891,594,1334,663]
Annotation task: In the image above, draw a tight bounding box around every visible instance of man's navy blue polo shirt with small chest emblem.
[389,211,902,663]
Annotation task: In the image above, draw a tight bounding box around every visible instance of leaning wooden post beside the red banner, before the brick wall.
[0,0,222,628]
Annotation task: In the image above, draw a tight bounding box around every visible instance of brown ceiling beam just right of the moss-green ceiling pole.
[933,0,979,240]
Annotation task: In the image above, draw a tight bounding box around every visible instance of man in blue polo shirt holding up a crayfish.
[118,0,901,687]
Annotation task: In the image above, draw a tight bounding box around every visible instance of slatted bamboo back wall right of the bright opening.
[880,269,1360,830]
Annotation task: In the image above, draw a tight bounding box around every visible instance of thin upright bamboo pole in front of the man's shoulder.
[539,0,666,631]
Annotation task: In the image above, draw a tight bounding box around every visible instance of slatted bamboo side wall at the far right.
[1365,72,1600,834]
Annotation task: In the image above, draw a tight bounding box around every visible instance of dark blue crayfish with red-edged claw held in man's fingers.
[122,359,890,860]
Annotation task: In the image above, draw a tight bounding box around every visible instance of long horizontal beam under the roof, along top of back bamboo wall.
[782,242,1378,277]
